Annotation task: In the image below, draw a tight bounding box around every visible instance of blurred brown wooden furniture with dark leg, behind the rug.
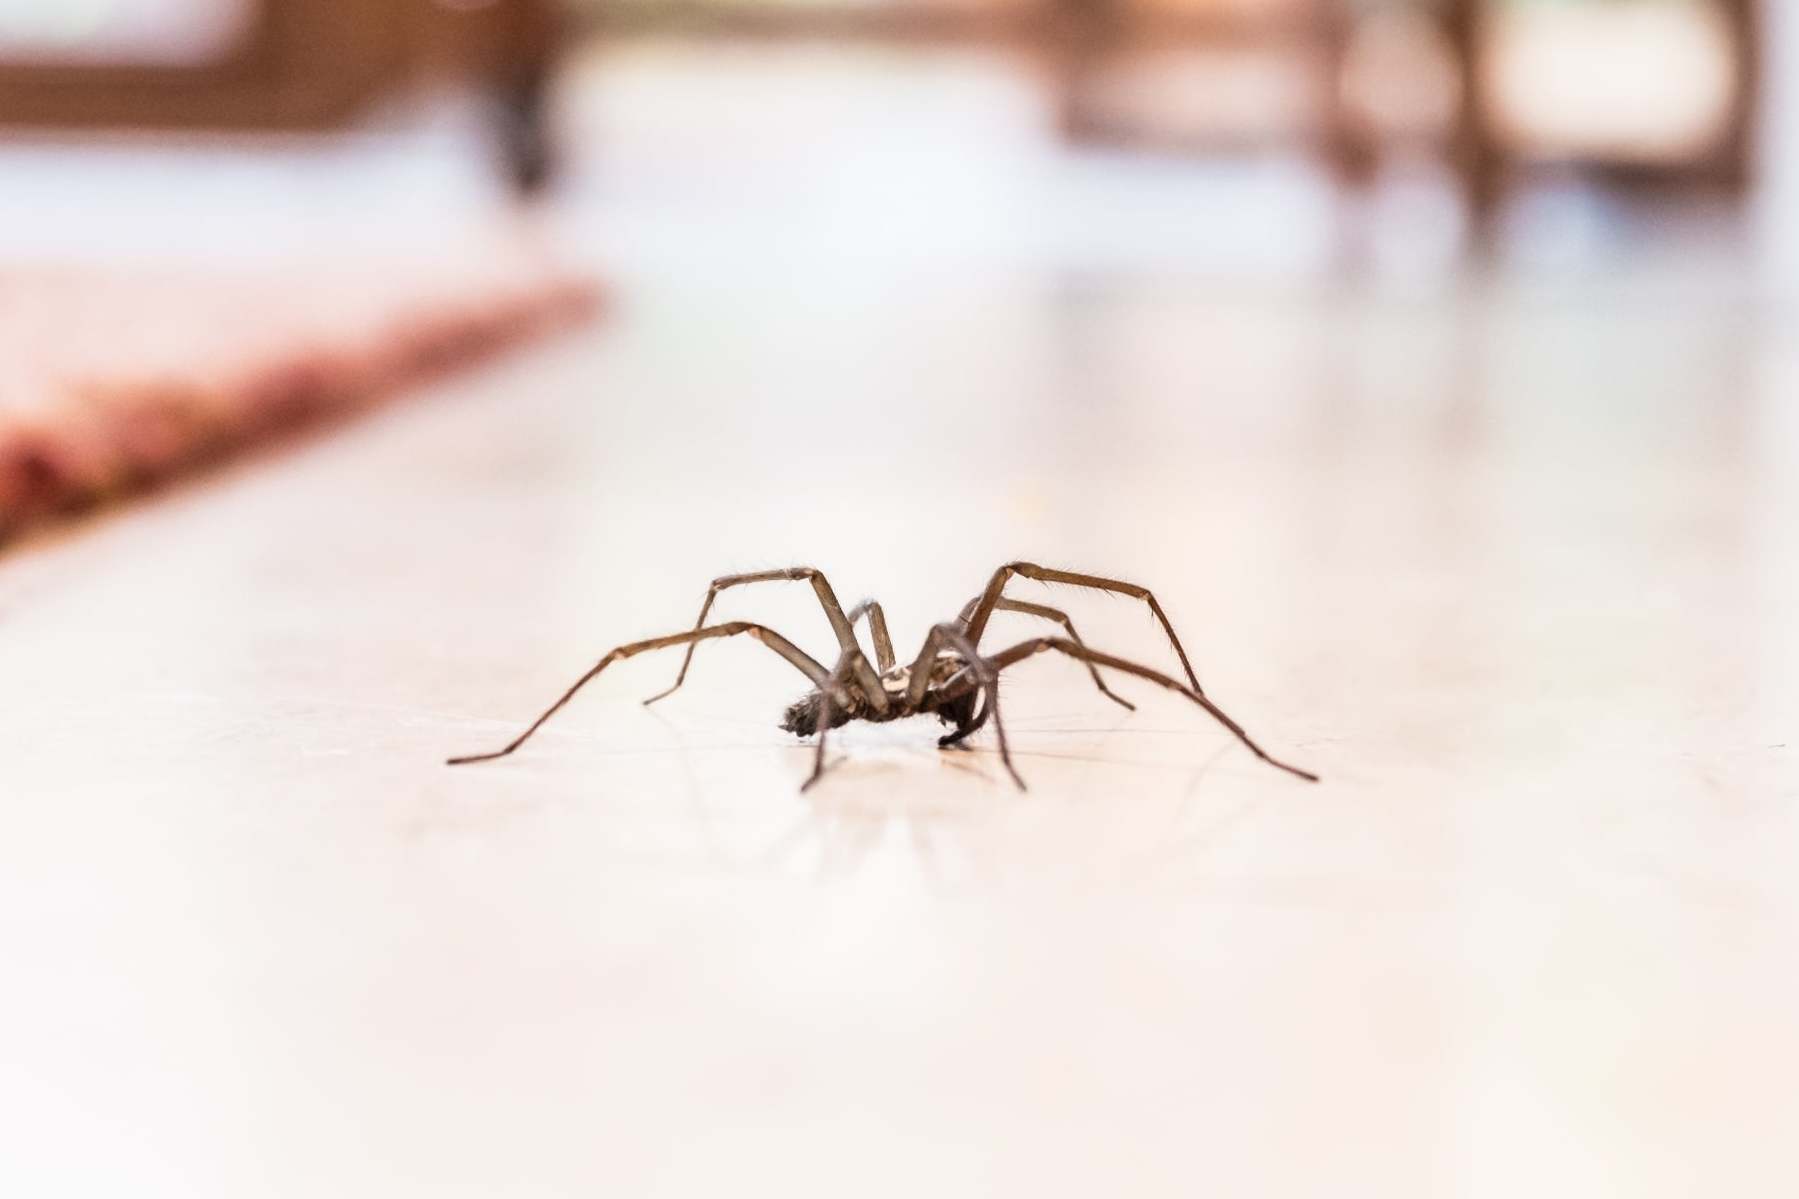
[0,0,563,191]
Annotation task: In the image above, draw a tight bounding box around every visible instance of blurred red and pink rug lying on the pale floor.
[0,263,599,536]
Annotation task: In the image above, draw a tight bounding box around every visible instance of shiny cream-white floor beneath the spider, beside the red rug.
[0,39,1799,1197]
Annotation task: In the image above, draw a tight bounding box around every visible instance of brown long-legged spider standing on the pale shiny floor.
[450,562,1319,790]
